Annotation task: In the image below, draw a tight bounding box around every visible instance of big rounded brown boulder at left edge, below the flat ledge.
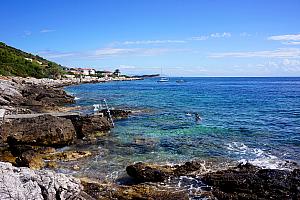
[1,115,76,146]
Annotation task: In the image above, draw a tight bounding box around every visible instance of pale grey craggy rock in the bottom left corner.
[0,162,91,200]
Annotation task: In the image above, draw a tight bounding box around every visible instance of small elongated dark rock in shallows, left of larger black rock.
[126,161,204,182]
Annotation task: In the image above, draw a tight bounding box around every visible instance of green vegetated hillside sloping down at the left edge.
[0,42,64,78]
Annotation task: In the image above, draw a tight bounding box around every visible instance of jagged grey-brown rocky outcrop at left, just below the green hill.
[0,78,75,113]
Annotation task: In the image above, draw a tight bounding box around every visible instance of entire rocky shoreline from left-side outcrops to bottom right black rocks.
[0,77,300,200]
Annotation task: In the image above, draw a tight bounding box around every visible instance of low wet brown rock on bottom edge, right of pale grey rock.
[81,179,189,200]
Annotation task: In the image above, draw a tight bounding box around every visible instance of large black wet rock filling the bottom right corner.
[203,164,300,200]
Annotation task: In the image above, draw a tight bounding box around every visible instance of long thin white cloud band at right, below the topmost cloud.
[209,48,300,58]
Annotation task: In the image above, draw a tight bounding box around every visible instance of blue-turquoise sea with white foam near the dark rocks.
[66,78,300,180]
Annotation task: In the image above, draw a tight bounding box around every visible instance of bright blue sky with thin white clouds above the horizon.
[0,0,300,76]
